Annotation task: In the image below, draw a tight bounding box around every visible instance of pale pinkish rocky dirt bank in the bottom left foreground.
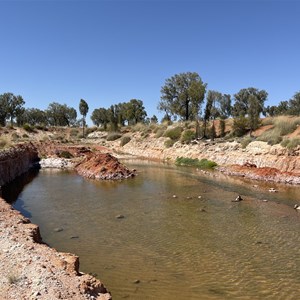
[0,198,110,300]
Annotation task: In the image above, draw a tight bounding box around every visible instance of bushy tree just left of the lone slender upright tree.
[46,102,77,127]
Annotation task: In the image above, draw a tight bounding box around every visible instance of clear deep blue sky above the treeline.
[0,0,300,123]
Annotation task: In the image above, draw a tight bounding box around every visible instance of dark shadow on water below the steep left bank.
[1,168,39,218]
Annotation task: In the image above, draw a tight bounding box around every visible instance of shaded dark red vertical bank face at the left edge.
[0,143,39,186]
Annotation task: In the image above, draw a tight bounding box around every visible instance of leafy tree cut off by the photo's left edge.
[0,93,25,126]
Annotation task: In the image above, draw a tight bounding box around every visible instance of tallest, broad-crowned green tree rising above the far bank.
[158,72,206,121]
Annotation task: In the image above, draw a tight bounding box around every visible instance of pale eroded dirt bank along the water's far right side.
[91,133,300,185]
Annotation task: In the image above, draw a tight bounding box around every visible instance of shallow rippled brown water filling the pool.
[4,162,300,300]
